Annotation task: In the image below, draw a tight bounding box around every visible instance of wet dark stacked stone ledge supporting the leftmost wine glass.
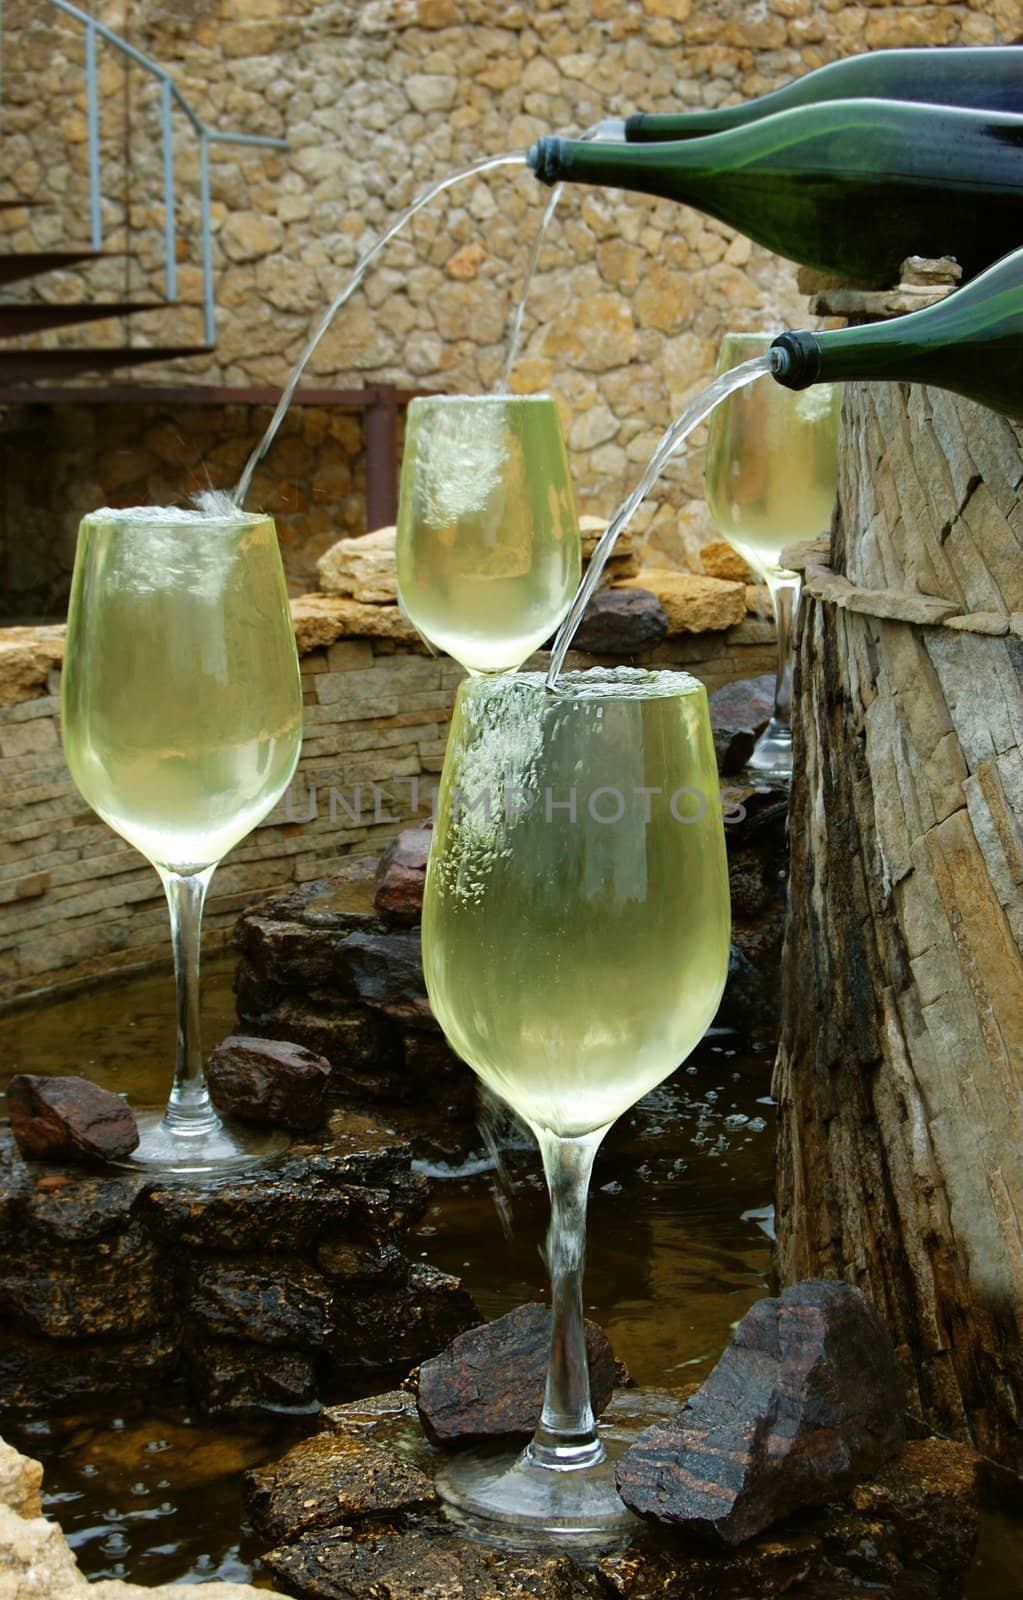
[0,1110,479,1416]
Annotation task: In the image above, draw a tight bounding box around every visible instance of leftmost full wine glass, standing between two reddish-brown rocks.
[61,507,303,1173]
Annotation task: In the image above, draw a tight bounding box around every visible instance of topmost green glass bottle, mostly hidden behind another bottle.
[624,45,1023,144]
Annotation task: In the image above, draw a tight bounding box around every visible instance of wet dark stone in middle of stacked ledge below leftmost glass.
[187,1256,333,1350]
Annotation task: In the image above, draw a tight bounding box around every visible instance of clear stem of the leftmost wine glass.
[160,867,221,1136]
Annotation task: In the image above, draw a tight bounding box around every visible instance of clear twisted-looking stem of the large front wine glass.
[528,1130,604,1470]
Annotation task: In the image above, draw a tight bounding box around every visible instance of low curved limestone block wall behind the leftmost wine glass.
[0,597,775,1005]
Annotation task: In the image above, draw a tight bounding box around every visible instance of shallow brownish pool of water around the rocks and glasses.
[0,957,1023,1600]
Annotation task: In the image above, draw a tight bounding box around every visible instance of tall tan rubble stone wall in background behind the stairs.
[0,0,1023,611]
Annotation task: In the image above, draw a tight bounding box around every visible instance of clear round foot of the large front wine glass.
[437,1450,642,1549]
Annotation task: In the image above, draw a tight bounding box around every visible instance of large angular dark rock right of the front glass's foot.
[616,1278,906,1544]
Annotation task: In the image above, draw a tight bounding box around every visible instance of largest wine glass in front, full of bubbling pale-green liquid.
[423,667,730,1534]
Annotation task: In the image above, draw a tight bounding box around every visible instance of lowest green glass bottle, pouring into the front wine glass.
[770,250,1023,421]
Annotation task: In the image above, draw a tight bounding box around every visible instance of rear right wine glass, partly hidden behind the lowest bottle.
[706,333,842,782]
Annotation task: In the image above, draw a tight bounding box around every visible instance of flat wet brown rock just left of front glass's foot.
[245,1432,437,1542]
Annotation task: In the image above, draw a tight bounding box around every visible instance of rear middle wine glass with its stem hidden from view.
[395,395,581,674]
